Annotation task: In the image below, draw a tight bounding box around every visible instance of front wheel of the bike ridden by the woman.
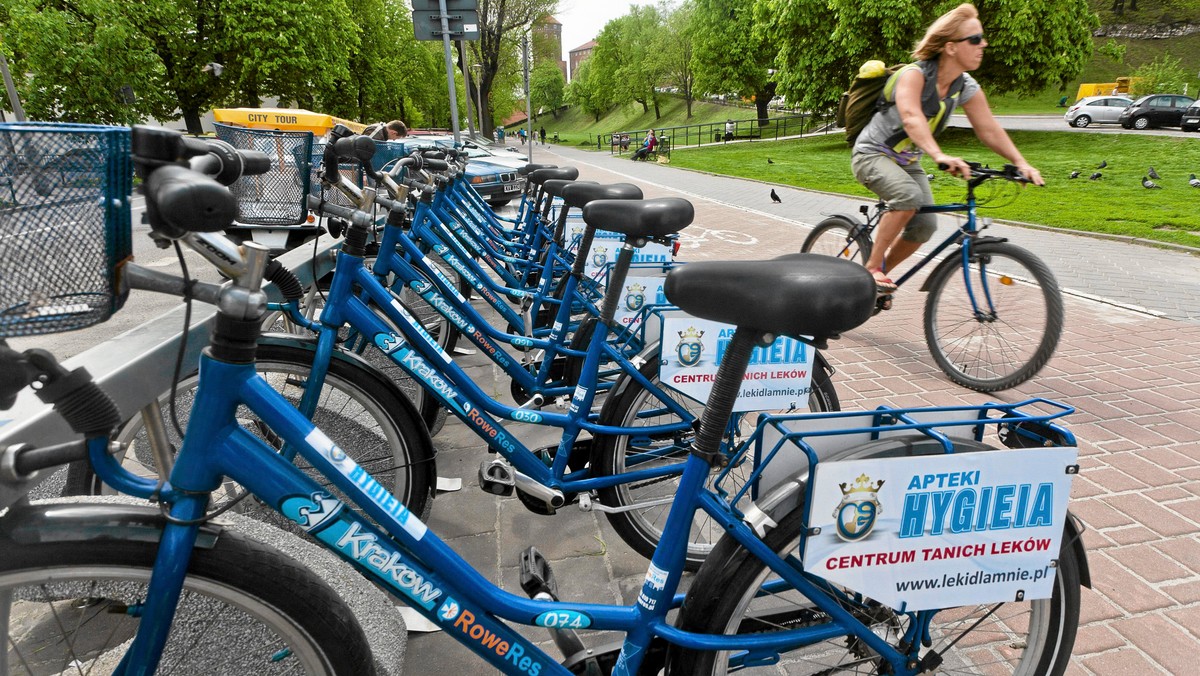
[924,241,1063,393]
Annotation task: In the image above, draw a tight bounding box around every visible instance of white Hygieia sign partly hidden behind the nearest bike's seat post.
[659,316,815,412]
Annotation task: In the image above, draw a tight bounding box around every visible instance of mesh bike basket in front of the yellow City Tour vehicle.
[214,124,312,226]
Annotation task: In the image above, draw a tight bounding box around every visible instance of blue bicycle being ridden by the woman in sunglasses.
[800,162,1063,391]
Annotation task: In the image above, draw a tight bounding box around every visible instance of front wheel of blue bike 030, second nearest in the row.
[66,343,436,526]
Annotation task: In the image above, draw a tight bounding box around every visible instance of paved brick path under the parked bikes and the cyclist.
[407,141,1200,676]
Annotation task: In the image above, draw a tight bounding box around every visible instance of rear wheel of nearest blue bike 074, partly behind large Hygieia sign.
[667,437,1082,676]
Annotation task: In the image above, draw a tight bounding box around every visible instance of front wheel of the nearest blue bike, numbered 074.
[0,523,374,676]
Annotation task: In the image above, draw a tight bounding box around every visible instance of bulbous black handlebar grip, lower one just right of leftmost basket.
[145,164,238,238]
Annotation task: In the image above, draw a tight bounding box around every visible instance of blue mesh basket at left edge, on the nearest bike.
[0,122,133,339]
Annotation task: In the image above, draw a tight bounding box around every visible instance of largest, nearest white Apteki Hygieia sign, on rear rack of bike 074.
[804,448,1078,611]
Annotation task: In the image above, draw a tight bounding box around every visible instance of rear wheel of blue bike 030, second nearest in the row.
[592,355,840,570]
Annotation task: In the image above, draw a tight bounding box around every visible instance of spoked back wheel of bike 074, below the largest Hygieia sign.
[668,507,1080,676]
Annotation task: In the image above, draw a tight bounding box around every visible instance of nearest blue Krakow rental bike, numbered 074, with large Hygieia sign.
[0,126,1087,676]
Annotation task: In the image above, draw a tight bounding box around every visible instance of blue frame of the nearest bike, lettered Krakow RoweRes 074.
[90,354,913,676]
